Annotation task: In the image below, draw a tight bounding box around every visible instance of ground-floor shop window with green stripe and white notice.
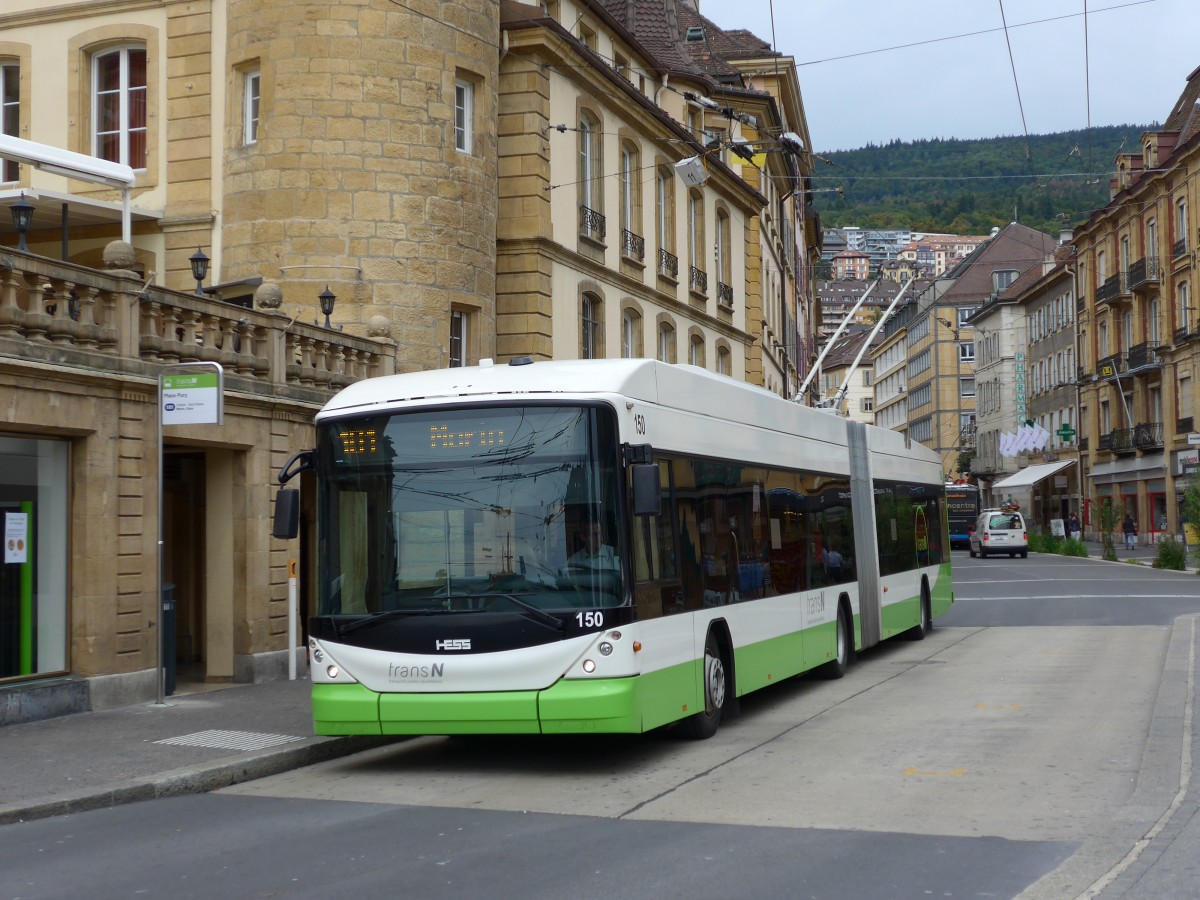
[0,437,71,678]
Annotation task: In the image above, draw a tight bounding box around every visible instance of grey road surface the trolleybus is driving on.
[0,553,1200,900]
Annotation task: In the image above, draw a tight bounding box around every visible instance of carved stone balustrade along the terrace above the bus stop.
[0,252,395,391]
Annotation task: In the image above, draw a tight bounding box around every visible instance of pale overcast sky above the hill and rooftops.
[700,0,1200,152]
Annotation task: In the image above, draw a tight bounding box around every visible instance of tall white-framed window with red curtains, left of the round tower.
[91,47,146,169]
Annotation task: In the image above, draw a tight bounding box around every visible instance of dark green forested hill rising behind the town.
[812,125,1154,240]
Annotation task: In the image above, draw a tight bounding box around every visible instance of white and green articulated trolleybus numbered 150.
[275,359,953,738]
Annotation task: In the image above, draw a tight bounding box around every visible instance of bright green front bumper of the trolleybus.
[312,678,643,734]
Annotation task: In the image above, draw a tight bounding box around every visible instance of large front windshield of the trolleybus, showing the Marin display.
[317,406,626,616]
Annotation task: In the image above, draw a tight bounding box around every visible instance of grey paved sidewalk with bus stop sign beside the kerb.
[0,678,397,824]
